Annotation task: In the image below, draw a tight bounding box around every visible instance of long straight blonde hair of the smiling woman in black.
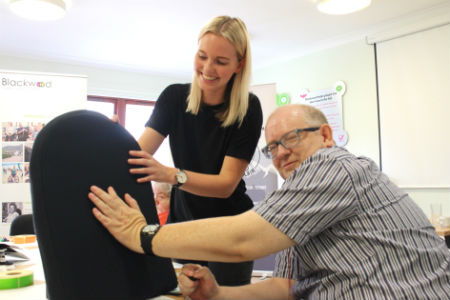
[186,16,252,127]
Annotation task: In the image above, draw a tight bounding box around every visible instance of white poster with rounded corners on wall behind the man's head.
[297,81,348,146]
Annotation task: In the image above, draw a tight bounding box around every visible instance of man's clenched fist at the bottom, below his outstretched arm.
[178,264,220,299]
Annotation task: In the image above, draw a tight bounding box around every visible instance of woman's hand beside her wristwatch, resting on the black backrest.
[128,150,177,184]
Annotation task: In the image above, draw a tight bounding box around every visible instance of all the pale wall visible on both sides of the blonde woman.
[0,35,450,220]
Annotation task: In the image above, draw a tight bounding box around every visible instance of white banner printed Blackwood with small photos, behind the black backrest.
[0,70,87,237]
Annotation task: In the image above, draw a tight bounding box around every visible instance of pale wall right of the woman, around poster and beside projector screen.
[253,40,450,216]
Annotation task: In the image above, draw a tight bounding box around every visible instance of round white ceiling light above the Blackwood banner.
[9,0,66,21]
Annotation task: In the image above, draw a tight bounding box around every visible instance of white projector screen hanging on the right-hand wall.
[376,24,450,188]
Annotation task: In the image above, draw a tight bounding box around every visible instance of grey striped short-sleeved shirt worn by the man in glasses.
[254,147,450,299]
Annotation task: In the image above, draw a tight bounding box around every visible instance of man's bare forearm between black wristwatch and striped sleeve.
[152,210,294,262]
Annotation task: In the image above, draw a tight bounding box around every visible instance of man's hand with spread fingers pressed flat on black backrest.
[88,186,147,253]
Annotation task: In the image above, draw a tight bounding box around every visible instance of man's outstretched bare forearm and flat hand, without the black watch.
[89,187,295,262]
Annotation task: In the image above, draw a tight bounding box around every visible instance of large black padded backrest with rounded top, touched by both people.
[30,110,177,299]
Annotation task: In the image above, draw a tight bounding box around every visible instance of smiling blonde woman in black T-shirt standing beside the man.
[129,16,262,285]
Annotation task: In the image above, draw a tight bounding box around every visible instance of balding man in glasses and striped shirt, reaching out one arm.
[89,105,450,299]
